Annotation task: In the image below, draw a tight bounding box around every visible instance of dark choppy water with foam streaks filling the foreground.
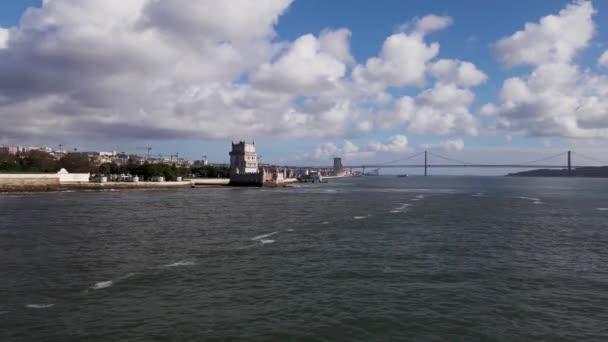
[0,177,608,341]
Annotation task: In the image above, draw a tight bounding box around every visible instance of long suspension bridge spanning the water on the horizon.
[344,151,608,176]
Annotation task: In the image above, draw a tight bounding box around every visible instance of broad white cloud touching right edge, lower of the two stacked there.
[499,64,608,138]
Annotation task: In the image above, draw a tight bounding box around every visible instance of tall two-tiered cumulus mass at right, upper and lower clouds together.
[497,1,608,138]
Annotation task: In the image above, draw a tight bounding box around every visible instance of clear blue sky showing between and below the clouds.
[0,0,608,170]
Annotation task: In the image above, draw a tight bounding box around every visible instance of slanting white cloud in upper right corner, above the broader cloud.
[495,1,595,66]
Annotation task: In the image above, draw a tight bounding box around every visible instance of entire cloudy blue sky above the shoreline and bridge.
[0,0,608,164]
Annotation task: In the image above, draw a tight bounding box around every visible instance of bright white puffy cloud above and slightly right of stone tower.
[251,32,350,95]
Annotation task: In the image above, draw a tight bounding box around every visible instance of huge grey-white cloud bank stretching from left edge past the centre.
[0,0,487,144]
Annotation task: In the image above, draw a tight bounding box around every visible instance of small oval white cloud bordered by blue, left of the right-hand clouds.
[429,59,488,87]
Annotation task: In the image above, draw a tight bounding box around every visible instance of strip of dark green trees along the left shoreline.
[0,151,229,180]
